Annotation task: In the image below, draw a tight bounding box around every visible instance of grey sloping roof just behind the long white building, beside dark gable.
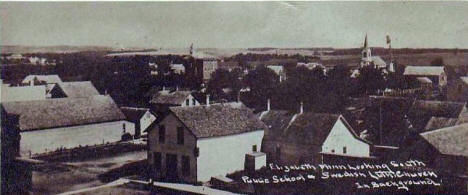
[58,81,99,98]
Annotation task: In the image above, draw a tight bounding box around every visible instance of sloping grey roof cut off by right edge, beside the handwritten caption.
[421,124,468,157]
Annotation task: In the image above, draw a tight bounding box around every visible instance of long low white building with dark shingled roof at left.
[2,95,134,157]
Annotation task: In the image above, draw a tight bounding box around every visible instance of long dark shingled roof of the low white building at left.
[2,95,125,131]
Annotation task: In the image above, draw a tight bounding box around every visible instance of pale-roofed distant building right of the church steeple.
[403,66,447,87]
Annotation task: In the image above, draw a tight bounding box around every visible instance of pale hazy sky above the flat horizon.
[0,1,468,48]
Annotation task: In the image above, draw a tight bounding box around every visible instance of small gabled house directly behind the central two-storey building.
[150,90,200,115]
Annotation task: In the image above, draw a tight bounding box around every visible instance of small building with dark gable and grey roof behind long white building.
[48,81,99,98]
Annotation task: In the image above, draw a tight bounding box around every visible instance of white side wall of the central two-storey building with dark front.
[197,130,264,181]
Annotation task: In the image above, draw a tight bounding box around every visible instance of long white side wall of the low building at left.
[20,121,134,156]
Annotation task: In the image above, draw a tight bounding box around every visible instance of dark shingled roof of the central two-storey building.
[169,102,266,138]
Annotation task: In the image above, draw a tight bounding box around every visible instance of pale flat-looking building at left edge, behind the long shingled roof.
[0,84,46,102]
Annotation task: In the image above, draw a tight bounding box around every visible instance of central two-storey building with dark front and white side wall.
[148,102,265,182]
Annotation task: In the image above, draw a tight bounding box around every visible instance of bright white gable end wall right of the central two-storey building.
[322,119,370,157]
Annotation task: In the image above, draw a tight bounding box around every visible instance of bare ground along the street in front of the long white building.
[32,151,146,194]
